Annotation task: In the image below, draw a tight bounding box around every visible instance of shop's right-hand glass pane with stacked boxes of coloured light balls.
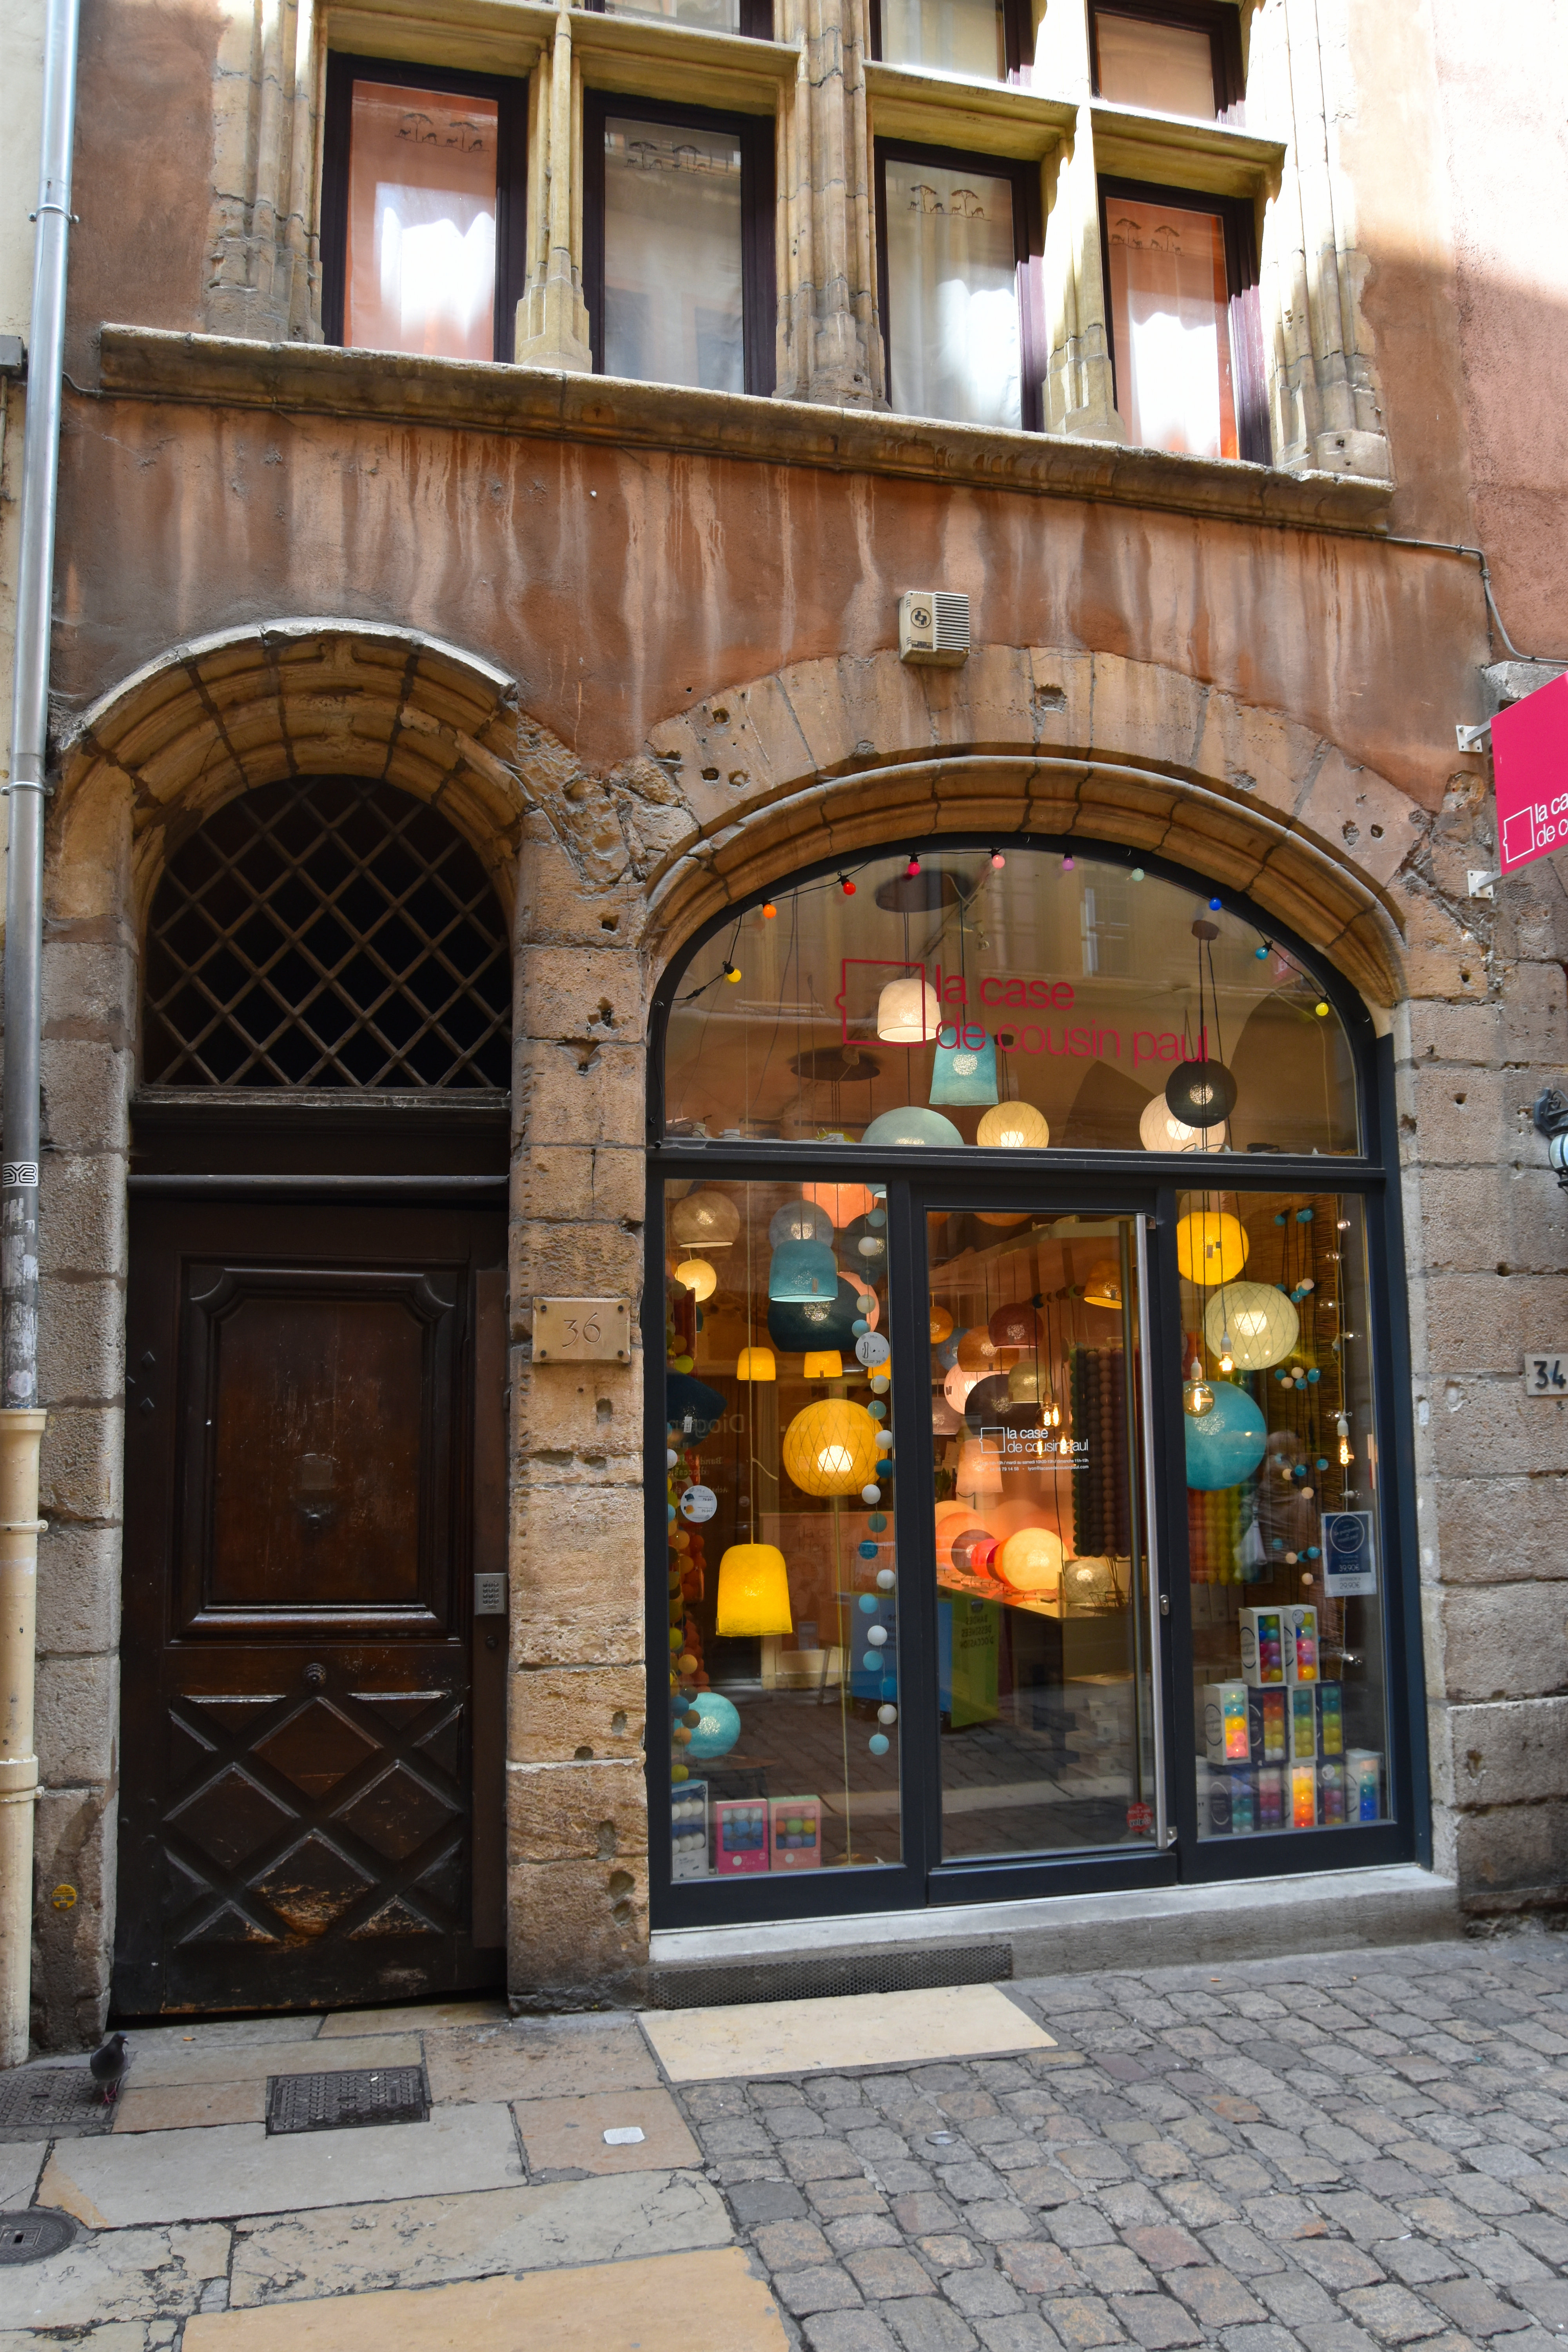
[1176,1190,1389,1839]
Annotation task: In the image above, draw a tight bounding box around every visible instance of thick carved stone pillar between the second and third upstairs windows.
[778,0,886,409]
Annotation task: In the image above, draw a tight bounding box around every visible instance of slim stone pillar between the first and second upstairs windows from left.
[517,9,592,376]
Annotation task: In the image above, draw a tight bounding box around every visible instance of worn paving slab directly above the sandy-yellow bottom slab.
[228,2173,733,2296]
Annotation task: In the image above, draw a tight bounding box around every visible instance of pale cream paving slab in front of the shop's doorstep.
[639,1985,1053,2082]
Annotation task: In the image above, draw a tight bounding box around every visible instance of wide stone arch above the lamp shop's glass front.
[639,644,1425,1007]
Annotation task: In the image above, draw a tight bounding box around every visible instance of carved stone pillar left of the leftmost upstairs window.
[202,0,322,343]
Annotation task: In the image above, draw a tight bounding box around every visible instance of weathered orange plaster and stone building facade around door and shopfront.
[12,0,1568,2046]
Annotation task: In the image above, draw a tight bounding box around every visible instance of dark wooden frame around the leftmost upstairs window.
[322,49,529,362]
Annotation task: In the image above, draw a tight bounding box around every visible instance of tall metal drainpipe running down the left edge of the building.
[0,0,78,2065]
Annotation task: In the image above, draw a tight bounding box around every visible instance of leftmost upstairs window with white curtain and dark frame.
[322,54,526,360]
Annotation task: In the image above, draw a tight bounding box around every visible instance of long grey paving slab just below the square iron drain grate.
[38,2107,522,2230]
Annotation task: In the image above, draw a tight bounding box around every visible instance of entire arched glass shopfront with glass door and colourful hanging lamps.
[646,844,1413,1922]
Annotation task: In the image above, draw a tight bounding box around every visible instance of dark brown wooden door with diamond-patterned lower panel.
[115,1200,505,2016]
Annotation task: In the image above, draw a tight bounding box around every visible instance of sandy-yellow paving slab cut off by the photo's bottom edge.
[183,2246,790,2352]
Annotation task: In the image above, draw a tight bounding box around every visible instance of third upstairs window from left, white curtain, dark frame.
[877,141,1039,430]
